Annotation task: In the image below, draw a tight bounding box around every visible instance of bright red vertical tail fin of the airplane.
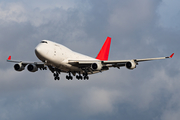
[96,37,111,60]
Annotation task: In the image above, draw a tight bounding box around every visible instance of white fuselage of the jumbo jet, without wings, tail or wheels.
[35,40,97,72]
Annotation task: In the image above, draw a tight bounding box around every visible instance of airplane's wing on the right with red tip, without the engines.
[68,53,174,70]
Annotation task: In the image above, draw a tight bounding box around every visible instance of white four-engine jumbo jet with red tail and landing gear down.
[7,37,174,80]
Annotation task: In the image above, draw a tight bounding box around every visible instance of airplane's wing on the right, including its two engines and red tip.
[68,53,174,71]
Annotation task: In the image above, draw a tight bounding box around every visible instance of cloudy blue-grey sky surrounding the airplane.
[0,0,180,120]
